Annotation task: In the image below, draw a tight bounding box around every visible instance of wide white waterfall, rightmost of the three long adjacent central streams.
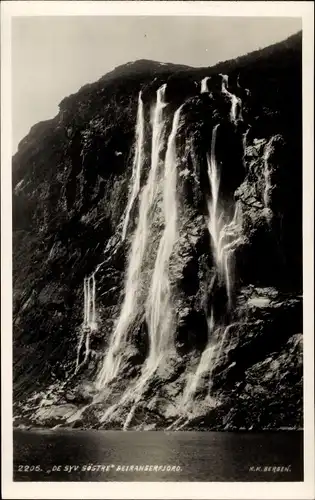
[123,102,182,429]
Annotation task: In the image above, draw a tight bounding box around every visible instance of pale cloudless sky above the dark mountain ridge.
[12,16,302,152]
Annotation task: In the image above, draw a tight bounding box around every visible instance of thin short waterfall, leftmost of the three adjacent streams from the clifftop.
[121,90,144,241]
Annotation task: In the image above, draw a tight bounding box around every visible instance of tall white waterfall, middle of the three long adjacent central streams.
[96,84,166,388]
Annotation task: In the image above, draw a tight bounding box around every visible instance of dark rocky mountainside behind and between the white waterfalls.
[12,34,302,429]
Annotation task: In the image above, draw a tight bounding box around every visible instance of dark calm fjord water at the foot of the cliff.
[14,429,303,482]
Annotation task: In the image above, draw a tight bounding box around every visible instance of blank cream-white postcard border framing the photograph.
[1,1,315,500]
